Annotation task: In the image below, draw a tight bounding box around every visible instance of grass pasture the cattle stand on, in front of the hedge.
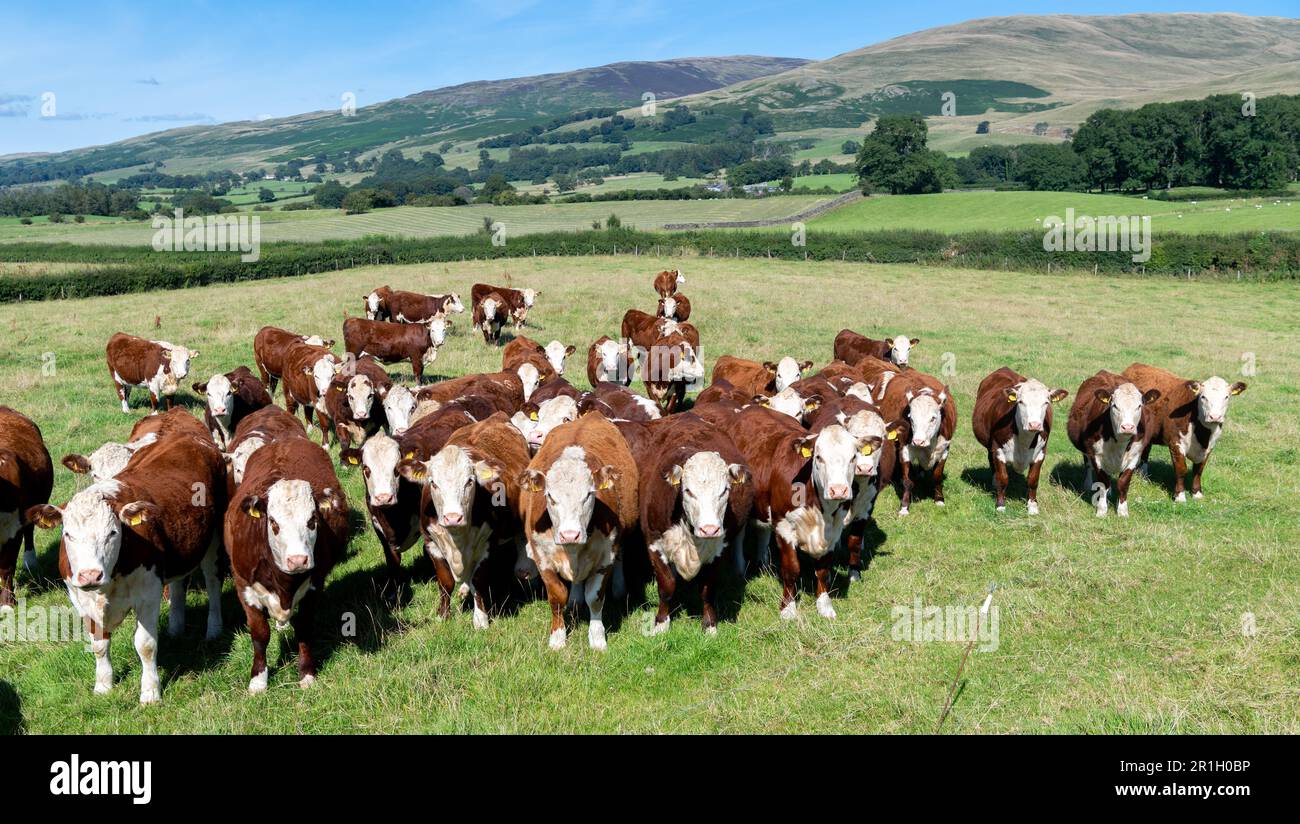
[0,257,1300,733]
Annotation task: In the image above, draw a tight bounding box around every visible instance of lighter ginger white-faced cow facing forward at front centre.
[519,412,638,650]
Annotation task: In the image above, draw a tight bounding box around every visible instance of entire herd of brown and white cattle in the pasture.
[0,272,1245,702]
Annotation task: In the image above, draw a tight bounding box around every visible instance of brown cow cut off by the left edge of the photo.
[0,406,55,610]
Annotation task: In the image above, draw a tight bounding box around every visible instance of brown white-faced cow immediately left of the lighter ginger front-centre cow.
[399,412,529,629]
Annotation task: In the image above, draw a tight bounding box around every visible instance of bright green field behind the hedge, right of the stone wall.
[809,191,1300,233]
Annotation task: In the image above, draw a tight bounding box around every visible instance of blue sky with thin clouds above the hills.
[0,0,1296,155]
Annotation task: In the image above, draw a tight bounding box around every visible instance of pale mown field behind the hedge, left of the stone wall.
[0,195,829,246]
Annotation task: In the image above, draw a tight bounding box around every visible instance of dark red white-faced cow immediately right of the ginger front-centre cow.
[620,413,754,634]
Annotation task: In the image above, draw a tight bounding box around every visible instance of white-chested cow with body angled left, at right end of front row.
[727,407,863,619]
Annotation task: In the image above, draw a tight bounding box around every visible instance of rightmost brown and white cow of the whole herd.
[1123,364,1245,503]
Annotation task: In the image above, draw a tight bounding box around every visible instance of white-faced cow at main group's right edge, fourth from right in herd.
[880,369,957,515]
